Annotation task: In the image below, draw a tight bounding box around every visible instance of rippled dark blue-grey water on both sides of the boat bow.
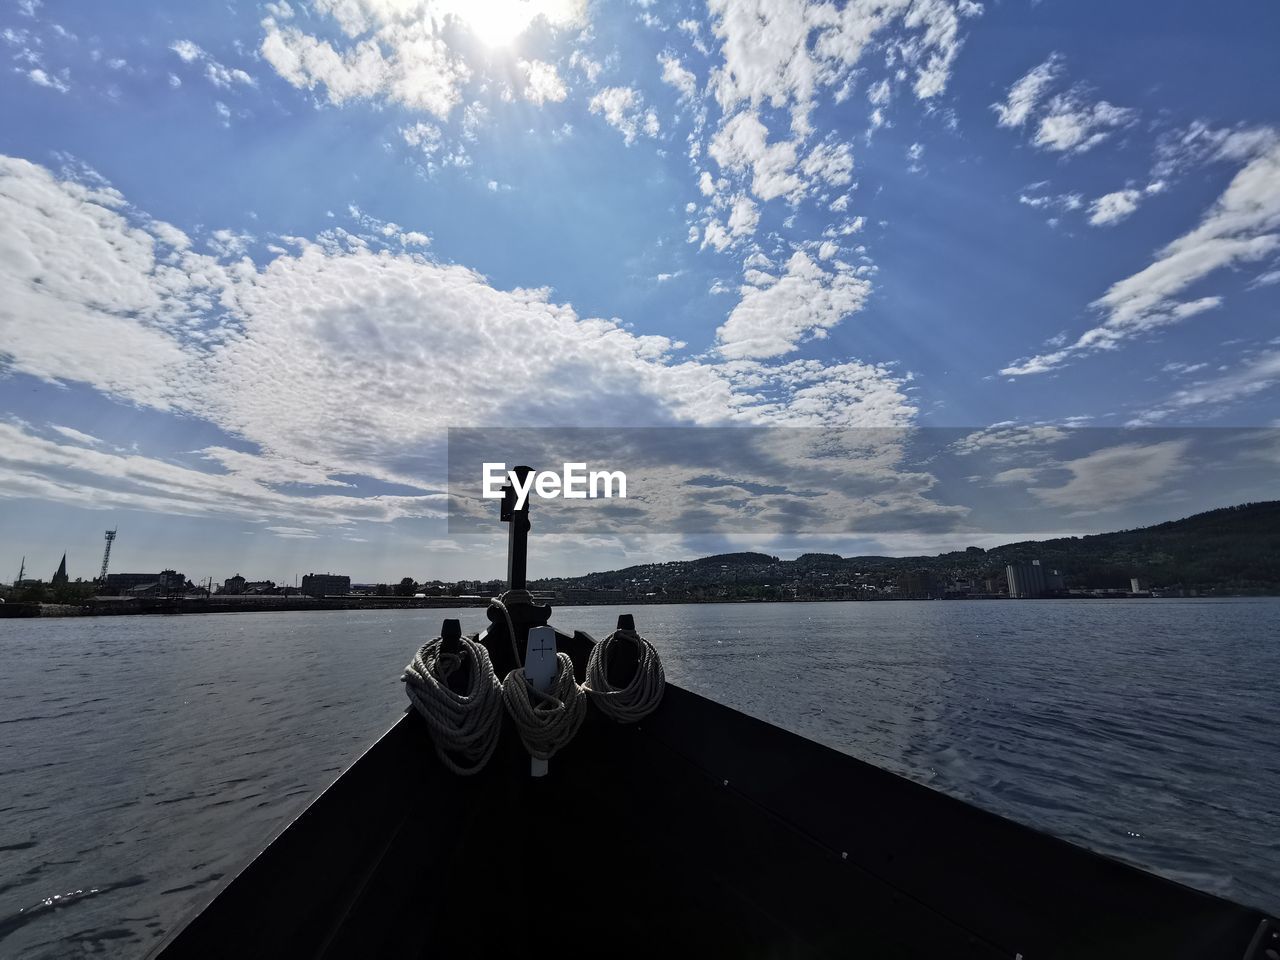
[0,600,1280,957]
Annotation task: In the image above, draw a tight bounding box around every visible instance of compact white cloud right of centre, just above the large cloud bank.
[716,251,870,360]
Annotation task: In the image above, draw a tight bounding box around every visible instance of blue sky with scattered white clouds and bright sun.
[0,0,1280,582]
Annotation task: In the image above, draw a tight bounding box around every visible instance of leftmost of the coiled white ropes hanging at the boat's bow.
[402,637,502,777]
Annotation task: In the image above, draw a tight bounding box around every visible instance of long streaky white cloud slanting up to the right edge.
[1001,141,1280,376]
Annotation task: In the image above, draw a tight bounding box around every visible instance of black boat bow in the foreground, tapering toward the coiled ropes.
[147,635,1280,960]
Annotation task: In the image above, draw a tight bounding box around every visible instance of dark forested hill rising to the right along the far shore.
[535,500,1280,598]
